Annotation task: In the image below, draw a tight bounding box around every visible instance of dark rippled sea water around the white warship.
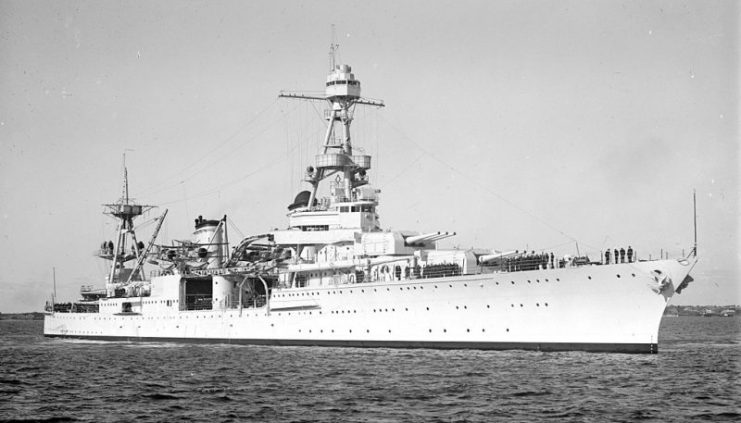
[0,317,741,422]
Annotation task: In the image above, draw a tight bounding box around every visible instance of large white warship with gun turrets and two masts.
[44,45,697,353]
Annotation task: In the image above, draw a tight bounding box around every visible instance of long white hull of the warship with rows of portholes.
[44,260,692,353]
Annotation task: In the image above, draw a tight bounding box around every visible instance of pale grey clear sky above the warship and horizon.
[0,0,741,313]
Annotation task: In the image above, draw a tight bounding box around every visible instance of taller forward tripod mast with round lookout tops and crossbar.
[279,36,384,209]
